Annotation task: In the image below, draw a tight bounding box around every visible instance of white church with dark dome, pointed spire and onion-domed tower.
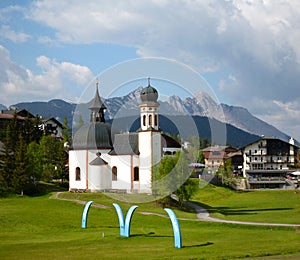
[69,79,181,194]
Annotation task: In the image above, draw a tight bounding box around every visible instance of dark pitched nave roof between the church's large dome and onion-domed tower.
[109,133,139,155]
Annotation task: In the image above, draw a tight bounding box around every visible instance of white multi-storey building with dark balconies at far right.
[242,137,299,189]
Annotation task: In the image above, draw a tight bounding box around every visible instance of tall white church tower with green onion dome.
[138,78,162,193]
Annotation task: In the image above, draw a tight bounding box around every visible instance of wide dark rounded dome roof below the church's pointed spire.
[72,122,113,149]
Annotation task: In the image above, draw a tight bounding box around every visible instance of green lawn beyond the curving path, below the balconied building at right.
[192,181,300,224]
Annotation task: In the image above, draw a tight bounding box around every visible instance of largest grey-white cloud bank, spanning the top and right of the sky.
[4,0,300,138]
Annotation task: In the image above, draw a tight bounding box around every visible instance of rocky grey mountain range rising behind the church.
[0,87,290,146]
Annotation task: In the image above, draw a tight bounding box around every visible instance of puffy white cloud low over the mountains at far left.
[0,45,93,105]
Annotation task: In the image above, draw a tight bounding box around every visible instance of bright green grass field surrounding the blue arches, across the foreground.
[0,186,300,259]
